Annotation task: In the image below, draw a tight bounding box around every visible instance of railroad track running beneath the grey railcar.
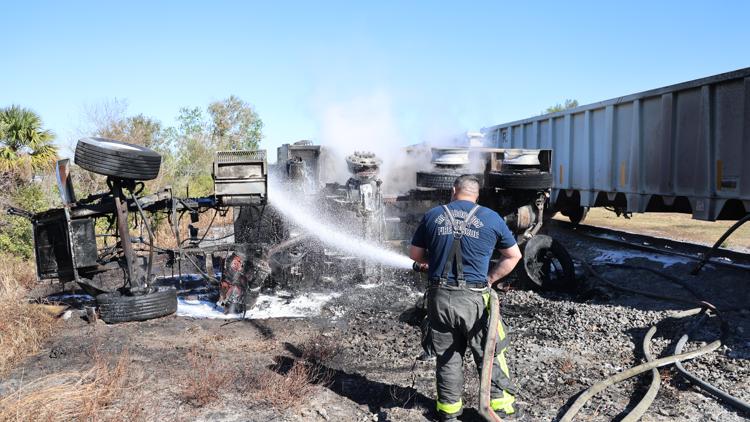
[545,220,750,272]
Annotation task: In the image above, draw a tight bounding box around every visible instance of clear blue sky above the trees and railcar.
[0,0,750,156]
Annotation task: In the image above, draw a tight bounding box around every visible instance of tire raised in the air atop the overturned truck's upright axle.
[75,138,161,180]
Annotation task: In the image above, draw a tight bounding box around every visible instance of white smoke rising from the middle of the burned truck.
[319,91,458,193]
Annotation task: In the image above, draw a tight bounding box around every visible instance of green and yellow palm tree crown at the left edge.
[0,105,57,176]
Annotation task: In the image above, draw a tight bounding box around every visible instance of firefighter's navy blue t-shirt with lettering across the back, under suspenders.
[411,200,516,283]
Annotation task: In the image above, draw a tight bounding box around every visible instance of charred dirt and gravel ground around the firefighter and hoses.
[0,229,750,421]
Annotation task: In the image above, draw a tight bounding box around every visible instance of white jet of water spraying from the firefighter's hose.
[268,181,412,269]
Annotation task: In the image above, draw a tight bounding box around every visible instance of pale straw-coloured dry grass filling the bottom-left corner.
[0,353,133,421]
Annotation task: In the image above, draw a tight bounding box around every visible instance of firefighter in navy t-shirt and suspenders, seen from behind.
[409,175,521,421]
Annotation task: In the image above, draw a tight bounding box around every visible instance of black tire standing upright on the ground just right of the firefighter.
[521,234,577,291]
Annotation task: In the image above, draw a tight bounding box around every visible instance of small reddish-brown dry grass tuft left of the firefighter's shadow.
[179,347,239,407]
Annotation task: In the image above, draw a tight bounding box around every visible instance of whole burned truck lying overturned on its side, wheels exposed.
[10,138,575,323]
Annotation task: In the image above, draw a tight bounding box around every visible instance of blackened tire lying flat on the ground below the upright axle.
[96,289,177,324]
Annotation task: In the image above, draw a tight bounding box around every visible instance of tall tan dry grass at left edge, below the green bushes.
[0,255,55,374]
